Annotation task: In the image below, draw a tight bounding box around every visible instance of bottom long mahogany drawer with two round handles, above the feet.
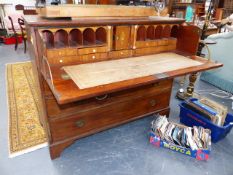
[50,91,170,142]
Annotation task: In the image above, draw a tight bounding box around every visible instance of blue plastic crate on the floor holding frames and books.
[180,99,233,143]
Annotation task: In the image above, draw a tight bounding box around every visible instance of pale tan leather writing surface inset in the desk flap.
[63,53,203,89]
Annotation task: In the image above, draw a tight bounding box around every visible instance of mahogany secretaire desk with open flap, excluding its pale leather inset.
[25,6,221,159]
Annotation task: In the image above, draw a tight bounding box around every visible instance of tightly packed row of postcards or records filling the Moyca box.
[151,115,211,150]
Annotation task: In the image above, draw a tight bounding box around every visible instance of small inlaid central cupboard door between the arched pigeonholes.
[113,26,130,50]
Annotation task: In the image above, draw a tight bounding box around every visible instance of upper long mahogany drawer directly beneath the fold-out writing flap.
[44,80,172,119]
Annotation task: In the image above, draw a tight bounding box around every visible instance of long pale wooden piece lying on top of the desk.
[37,5,156,18]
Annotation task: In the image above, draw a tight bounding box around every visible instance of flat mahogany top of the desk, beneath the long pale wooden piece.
[24,16,184,27]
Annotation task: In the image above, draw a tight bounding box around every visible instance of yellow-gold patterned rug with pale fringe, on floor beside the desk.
[7,62,47,157]
